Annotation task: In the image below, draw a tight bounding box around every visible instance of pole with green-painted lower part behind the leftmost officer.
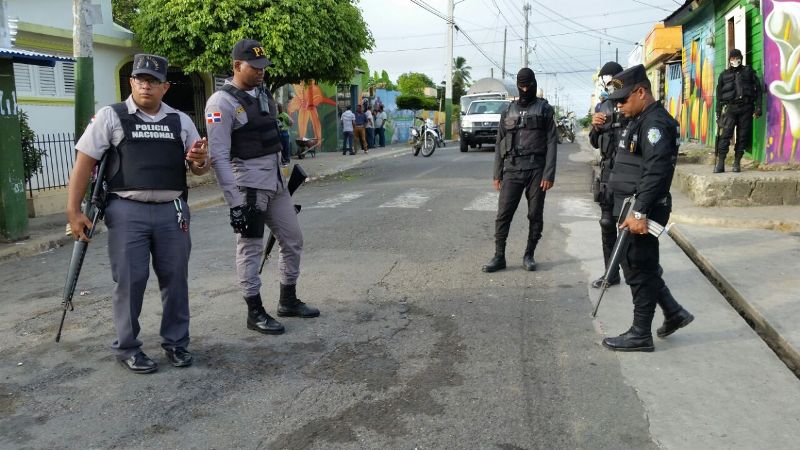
[72,0,95,139]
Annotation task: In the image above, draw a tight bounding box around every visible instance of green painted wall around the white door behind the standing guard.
[714,0,766,162]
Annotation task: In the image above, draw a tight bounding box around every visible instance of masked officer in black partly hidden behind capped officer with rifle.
[589,61,628,288]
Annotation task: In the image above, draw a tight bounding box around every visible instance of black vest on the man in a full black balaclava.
[503,99,553,170]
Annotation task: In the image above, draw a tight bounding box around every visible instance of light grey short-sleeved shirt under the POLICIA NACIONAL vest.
[75,96,200,202]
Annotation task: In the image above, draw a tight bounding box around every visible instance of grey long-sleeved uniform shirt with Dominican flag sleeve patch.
[206,80,285,207]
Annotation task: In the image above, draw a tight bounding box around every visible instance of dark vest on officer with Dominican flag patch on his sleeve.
[221,84,281,159]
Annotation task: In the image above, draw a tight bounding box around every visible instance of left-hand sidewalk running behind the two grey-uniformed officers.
[0,143,411,262]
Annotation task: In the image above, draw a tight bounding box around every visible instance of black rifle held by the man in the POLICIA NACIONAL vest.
[56,152,109,342]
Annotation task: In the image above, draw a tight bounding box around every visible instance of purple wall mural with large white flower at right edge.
[762,0,800,164]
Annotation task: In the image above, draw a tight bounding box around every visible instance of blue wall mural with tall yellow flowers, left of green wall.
[678,27,716,145]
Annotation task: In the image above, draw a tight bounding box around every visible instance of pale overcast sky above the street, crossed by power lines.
[360,0,683,115]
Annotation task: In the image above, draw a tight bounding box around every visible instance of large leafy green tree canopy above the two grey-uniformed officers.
[132,0,375,91]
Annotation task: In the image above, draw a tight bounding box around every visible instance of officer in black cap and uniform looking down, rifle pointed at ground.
[603,64,694,352]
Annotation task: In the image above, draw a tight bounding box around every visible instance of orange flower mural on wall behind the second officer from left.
[286,80,338,151]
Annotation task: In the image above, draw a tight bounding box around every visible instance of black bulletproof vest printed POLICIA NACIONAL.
[109,102,186,192]
